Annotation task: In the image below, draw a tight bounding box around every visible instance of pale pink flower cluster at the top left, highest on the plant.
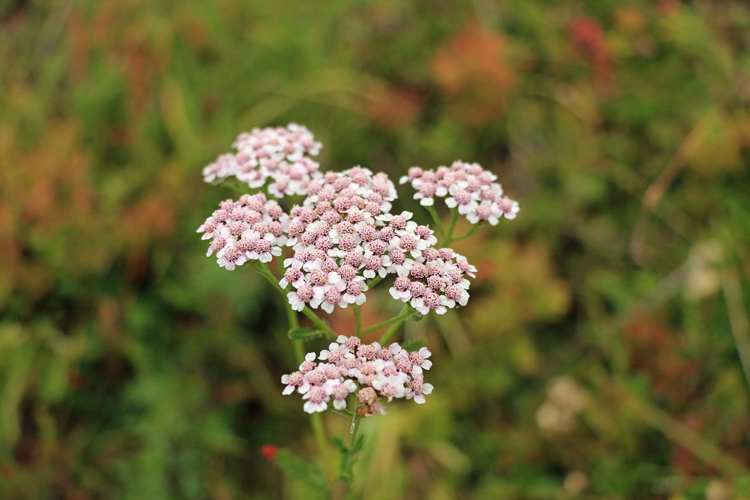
[203,123,322,198]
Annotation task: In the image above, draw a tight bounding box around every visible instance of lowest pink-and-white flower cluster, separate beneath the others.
[281,335,433,417]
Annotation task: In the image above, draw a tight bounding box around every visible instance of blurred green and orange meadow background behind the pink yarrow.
[0,0,750,500]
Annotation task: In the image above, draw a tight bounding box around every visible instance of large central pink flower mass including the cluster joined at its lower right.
[280,167,473,314]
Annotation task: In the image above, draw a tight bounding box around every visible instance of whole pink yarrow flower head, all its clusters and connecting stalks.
[198,124,518,416]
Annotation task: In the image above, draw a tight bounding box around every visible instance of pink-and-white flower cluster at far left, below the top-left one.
[198,193,289,271]
